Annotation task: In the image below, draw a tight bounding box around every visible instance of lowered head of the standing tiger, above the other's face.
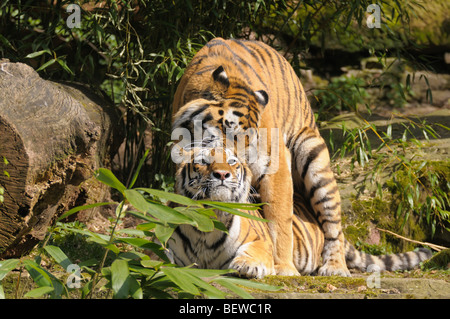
[173,66,269,143]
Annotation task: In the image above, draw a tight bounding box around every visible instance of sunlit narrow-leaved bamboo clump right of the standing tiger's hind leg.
[329,114,450,241]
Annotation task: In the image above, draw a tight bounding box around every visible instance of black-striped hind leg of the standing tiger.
[289,128,350,277]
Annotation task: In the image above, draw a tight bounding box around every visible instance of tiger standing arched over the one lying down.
[172,38,350,276]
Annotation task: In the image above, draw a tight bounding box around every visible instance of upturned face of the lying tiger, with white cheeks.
[175,147,251,202]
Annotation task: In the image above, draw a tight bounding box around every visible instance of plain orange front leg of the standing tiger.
[255,144,300,276]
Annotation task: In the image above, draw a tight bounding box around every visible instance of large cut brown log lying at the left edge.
[0,60,121,258]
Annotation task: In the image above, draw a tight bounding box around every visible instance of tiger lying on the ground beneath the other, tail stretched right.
[169,147,431,278]
